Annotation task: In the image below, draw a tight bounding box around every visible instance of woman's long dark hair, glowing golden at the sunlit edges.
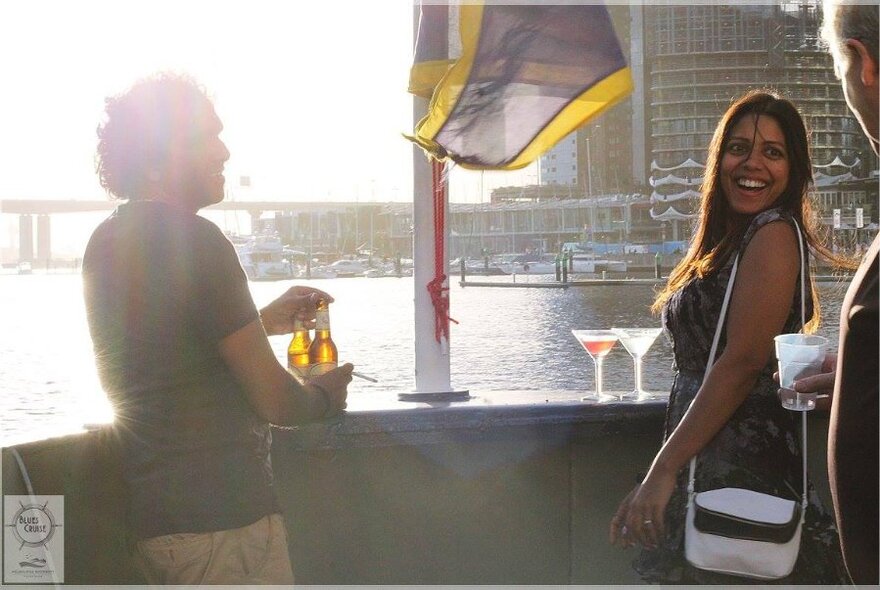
[651,91,850,332]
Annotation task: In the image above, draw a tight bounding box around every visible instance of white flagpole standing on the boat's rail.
[413,5,452,393]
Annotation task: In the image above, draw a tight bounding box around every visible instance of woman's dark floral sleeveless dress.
[633,209,848,584]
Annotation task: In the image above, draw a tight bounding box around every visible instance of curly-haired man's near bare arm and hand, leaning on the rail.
[220,320,353,425]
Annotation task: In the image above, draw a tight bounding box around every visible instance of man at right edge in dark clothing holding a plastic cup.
[795,0,880,585]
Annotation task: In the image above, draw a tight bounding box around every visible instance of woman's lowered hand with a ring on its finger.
[624,466,675,549]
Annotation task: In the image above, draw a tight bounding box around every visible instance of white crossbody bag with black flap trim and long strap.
[684,222,807,580]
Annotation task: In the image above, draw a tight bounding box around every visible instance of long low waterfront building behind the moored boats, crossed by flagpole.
[254,194,683,258]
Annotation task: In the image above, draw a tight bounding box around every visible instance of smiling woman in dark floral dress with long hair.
[611,91,842,584]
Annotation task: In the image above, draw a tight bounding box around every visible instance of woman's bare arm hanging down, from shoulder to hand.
[611,222,800,546]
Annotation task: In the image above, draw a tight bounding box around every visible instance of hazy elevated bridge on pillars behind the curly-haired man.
[0,197,389,263]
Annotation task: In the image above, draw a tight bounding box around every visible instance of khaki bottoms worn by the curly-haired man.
[135,514,293,584]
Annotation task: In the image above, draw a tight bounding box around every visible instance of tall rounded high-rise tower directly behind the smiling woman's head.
[644,2,877,225]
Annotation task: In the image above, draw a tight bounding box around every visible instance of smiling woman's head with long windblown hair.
[653,91,847,328]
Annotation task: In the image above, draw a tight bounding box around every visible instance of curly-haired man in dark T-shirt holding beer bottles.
[83,75,352,584]
